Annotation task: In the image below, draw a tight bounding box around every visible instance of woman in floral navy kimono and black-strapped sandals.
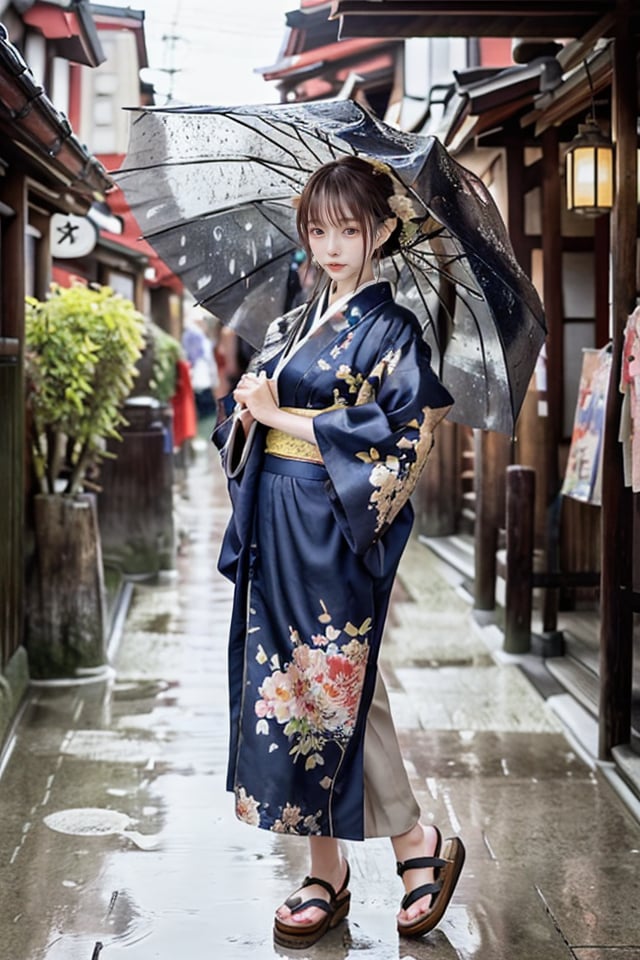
[214,157,464,947]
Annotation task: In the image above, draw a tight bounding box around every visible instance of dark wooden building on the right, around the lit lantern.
[332,0,640,808]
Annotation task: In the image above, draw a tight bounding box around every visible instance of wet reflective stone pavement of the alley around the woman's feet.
[0,452,640,960]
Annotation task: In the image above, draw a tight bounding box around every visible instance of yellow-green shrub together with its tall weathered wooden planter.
[25,284,144,678]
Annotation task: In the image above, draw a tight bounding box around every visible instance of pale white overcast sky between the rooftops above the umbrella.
[111,0,292,105]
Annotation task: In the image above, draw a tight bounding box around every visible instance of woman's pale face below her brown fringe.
[308,215,373,296]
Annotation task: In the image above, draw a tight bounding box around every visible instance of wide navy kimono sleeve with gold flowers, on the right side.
[314,323,453,555]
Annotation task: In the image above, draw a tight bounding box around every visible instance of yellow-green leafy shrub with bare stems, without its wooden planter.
[25,284,144,494]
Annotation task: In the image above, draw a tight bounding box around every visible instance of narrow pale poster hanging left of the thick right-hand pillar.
[561,347,611,506]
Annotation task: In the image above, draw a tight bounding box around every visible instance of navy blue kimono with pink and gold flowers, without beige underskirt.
[214,282,453,840]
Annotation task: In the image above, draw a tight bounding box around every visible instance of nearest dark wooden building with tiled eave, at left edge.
[0,4,111,734]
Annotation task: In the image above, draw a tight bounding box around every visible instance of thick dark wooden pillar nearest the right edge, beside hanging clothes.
[599,0,638,760]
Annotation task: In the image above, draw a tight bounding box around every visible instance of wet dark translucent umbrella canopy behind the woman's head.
[114,100,546,433]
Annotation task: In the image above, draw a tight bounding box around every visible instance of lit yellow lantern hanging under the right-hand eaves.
[565,117,614,217]
